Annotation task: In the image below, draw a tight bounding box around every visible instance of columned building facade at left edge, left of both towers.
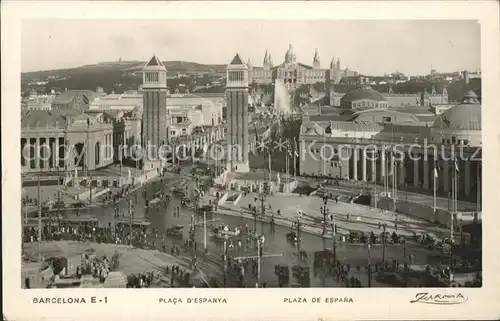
[21,110,135,173]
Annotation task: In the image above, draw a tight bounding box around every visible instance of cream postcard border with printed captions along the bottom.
[1,1,500,320]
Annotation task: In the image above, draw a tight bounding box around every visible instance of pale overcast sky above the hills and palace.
[22,19,481,75]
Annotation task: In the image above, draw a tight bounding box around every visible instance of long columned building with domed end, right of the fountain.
[300,91,482,201]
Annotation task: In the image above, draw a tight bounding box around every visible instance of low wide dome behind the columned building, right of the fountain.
[340,86,389,109]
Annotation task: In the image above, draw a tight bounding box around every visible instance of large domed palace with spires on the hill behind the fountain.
[247,45,356,89]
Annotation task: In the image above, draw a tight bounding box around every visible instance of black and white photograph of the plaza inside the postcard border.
[21,16,482,288]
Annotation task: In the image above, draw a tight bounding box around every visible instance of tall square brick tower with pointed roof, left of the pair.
[142,56,167,170]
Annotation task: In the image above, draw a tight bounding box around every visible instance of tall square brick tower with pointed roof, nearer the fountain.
[226,54,250,173]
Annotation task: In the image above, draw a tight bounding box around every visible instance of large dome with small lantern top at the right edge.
[431,91,481,146]
